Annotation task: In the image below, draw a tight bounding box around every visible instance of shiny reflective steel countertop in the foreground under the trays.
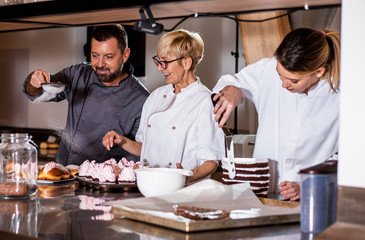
[0,182,302,240]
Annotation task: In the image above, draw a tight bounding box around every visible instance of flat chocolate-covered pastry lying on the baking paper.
[173,205,229,220]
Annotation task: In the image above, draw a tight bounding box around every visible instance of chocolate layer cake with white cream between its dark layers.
[222,158,270,197]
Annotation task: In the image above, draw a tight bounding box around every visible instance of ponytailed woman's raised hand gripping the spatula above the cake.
[213,85,242,127]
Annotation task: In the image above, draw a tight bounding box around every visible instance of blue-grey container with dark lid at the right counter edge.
[299,160,337,233]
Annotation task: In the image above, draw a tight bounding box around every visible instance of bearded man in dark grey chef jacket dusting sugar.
[23,25,149,165]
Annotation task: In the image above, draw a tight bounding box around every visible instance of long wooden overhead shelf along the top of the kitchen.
[0,0,341,33]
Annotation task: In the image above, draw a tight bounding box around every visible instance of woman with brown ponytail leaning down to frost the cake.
[213,28,340,201]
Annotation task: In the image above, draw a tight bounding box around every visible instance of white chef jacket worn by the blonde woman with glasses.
[136,78,225,170]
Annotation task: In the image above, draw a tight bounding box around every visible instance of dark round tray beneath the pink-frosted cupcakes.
[75,176,137,191]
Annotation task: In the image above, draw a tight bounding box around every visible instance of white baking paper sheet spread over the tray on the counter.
[108,179,300,221]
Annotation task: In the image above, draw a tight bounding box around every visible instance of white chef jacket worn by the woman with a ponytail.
[213,58,339,191]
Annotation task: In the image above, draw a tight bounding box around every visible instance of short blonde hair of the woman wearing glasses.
[156,29,204,72]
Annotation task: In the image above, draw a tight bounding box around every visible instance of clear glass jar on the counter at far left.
[0,133,38,198]
